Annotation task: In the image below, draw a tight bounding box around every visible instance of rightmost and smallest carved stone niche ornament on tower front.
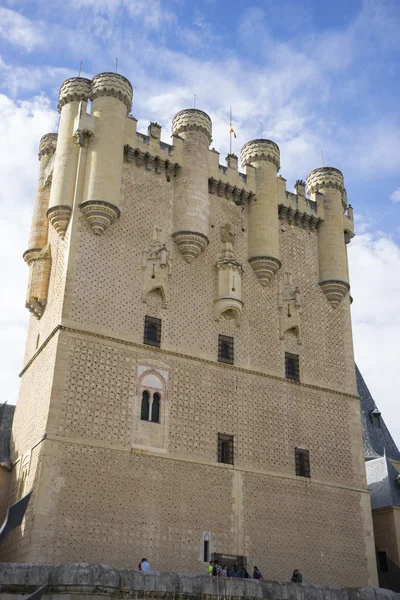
[278,271,301,344]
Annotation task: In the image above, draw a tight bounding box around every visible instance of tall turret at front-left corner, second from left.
[47,77,90,239]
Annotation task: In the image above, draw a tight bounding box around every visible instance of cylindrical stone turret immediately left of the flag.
[172,109,212,263]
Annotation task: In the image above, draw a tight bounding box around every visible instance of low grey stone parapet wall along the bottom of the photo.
[0,563,400,600]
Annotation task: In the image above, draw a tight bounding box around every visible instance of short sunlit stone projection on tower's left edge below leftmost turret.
[25,244,51,319]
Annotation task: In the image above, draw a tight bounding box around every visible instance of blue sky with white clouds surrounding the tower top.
[0,0,400,443]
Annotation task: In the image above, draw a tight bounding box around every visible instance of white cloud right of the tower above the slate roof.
[349,233,400,445]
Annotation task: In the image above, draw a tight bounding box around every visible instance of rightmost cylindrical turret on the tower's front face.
[307,167,350,308]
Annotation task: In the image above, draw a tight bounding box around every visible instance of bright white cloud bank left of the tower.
[0,94,57,403]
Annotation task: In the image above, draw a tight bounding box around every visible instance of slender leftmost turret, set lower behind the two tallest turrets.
[24,133,57,265]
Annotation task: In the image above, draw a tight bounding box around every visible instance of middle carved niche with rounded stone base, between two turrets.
[214,224,243,325]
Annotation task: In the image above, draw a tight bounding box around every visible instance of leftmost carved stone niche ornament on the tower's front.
[142,227,172,308]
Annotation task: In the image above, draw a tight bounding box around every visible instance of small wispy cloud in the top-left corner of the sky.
[0,7,46,52]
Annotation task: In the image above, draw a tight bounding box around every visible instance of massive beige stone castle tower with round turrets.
[3,73,376,586]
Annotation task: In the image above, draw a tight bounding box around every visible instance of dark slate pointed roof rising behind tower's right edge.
[356,366,400,461]
